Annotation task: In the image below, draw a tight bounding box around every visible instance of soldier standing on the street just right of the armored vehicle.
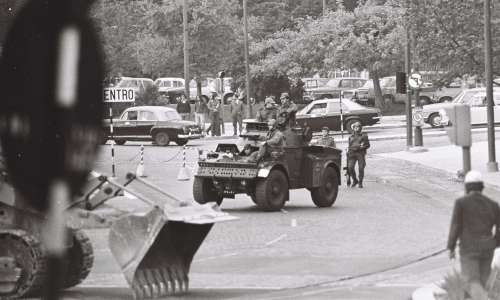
[347,121,370,188]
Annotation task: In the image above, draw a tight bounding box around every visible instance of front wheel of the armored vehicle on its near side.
[255,170,288,211]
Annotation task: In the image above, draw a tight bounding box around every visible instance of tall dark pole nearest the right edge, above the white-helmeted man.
[484,0,498,172]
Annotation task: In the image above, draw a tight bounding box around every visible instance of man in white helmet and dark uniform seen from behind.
[447,171,500,299]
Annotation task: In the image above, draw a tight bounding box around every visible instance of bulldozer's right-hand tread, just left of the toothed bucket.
[63,230,94,288]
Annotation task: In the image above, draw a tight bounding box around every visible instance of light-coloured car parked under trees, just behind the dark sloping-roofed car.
[303,77,367,101]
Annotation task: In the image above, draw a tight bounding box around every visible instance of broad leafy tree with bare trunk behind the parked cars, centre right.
[251,4,405,108]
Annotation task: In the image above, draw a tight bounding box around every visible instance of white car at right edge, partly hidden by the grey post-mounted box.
[422,87,500,127]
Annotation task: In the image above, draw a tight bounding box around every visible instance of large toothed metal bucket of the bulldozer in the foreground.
[109,205,234,299]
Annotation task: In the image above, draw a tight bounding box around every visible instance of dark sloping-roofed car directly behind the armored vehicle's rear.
[297,99,381,132]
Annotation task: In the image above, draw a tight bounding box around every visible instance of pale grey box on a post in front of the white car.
[440,104,472,147]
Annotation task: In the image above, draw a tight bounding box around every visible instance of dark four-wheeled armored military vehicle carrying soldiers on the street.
[193,122,342,211]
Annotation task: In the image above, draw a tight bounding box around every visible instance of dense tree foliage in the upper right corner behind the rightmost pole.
[404,0,500,84]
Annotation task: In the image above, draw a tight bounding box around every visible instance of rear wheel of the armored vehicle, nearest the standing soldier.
[311,167,339,207]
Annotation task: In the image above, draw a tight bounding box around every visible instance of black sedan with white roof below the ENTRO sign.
[103,106,203,146]
